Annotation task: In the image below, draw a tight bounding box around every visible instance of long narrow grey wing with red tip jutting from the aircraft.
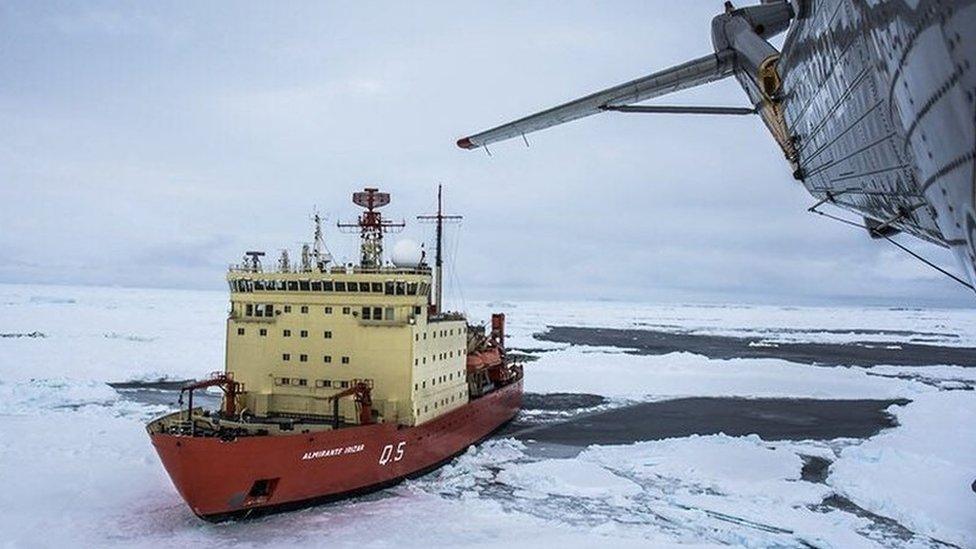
[457,50,735,149]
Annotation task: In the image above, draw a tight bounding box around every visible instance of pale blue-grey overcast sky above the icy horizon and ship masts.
[0,0,972,305]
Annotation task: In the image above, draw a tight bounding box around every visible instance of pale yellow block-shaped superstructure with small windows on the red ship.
[226,267,468,425]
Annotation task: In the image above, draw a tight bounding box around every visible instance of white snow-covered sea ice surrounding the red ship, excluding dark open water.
[0,285,976,547]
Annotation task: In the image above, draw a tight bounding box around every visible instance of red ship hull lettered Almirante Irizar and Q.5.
[151,378,522,520]
